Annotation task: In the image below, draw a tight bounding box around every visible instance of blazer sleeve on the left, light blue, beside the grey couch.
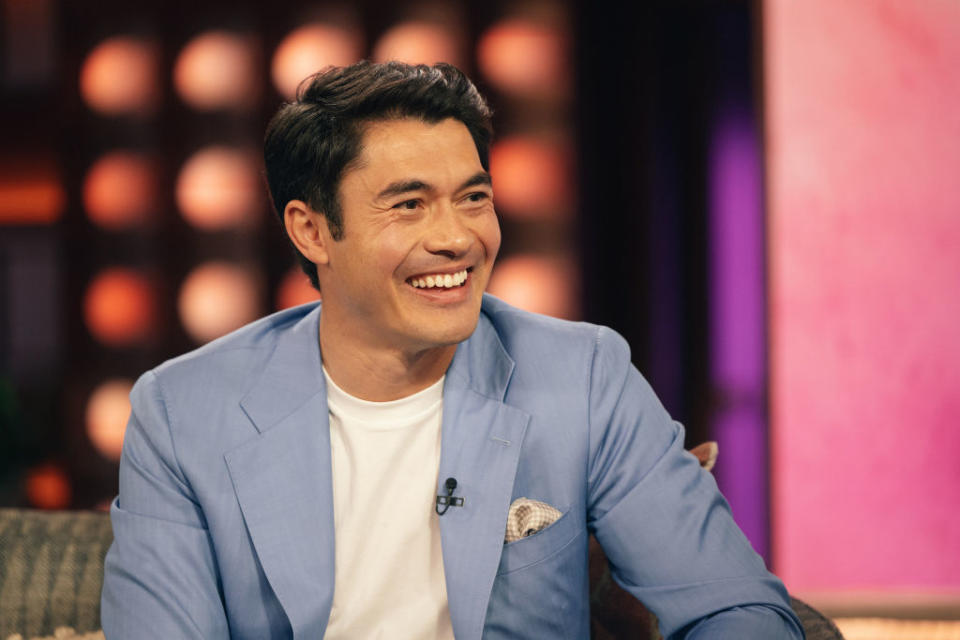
[101,372,230,639]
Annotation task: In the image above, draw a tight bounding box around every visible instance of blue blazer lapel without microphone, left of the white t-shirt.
[225,307,334,638]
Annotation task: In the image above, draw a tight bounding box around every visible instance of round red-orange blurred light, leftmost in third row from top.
[83,268,155,346]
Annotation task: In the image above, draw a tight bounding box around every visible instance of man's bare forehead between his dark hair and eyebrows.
[344,118,482,179]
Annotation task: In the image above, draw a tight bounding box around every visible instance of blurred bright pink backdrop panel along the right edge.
[764,0,960,594]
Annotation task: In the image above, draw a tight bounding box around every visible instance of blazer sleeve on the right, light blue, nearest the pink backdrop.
[587,328,804,639]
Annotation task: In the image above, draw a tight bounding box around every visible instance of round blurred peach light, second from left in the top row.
[173,31,260,110]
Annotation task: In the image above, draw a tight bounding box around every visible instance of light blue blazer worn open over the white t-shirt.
[102,296,802,640]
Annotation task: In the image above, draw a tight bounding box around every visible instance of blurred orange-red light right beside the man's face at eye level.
[490,137,573,218]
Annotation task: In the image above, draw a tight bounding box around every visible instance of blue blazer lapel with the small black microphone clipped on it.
[437,314,530,640]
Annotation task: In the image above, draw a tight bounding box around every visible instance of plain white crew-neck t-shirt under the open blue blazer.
[324,370,453,640]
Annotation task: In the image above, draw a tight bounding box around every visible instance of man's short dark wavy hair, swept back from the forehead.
[263,61,493,289]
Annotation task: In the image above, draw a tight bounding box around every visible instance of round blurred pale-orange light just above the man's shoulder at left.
[177,262,260,342]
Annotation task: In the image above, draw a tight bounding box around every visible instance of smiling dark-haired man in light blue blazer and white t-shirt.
[103,63,802,639]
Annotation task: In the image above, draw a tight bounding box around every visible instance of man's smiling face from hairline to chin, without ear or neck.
[318,118,500,354]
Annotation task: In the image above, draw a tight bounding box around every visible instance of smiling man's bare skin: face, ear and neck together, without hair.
[284,117,500,401]
